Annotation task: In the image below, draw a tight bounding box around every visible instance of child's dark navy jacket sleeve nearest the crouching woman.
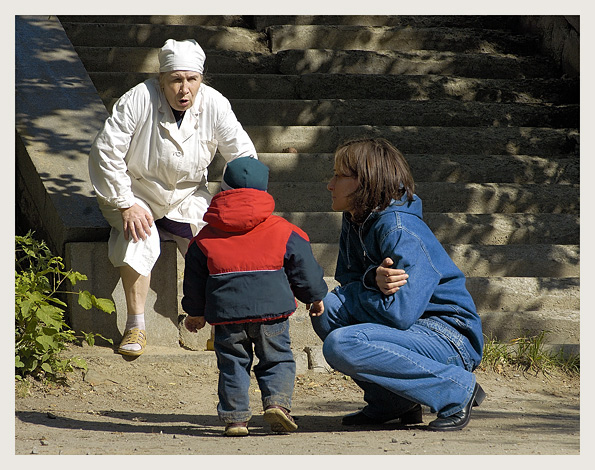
[284,232,328,304]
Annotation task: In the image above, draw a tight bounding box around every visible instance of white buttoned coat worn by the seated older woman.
[89,78,258,275]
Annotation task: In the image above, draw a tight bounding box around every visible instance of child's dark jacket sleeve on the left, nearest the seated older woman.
[182,242,209,317]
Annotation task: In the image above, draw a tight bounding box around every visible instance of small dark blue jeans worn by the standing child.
[214,318,295,423]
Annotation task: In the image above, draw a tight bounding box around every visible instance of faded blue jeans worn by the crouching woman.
[312,291,475,419]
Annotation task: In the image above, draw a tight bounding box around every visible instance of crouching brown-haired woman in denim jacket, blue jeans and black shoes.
[312,138,485,431]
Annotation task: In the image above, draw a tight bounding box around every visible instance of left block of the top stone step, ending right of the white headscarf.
[62,21,270,52]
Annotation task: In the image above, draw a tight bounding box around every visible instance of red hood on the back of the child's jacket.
[204,188,275,232]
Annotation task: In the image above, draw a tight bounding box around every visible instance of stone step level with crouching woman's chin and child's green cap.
[209,182,580,215]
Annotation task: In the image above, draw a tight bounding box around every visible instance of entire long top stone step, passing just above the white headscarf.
[62,21,539,55]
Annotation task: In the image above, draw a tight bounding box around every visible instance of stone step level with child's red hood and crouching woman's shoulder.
[275,211,580,245]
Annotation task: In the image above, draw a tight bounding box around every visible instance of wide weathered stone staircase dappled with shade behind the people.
[29,16,580,352]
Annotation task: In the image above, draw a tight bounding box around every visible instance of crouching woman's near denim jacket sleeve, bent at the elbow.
[346,230,441,330]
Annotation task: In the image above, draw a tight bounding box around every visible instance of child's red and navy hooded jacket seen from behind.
[182,188,328,325]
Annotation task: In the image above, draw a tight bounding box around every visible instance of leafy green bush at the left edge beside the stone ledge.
[15,231,115,380]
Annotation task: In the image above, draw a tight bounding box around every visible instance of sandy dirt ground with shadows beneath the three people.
[14,346,581,458]
